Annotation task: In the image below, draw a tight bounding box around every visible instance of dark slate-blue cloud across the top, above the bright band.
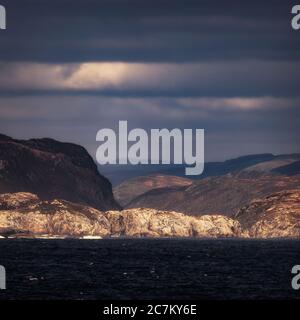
[0,0,300,62]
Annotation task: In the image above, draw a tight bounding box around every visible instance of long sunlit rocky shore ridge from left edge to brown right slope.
[0,193,242,237]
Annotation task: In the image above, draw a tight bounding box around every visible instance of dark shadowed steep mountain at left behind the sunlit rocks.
[0,135,120,210]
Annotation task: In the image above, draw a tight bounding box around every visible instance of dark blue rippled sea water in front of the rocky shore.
[0,239,300,299]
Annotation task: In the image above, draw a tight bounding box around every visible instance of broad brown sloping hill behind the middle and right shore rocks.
[126,172,300,217]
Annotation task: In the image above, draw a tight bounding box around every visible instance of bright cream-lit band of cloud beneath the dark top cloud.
[0,60,300,98]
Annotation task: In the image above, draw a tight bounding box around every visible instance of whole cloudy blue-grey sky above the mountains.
[0,0,300,161]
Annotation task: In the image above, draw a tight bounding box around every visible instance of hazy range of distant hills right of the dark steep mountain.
[113,153,300,210]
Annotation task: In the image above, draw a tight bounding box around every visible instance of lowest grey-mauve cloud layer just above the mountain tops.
[0,95,300,161]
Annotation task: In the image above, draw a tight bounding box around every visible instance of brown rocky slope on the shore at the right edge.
[235,189,300,238]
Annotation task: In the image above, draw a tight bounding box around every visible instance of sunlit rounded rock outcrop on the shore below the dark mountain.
[0,193,110,236]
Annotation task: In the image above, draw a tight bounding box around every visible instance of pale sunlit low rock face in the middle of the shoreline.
[106,208,241,237]
